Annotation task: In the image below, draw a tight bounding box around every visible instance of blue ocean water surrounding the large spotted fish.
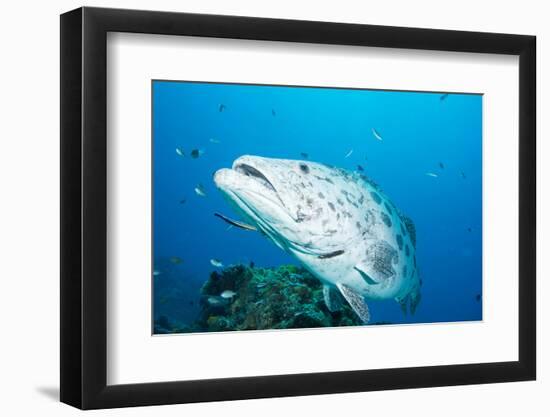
[152,81,482,332]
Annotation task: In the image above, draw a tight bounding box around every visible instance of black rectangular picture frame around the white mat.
[60,7,536,409]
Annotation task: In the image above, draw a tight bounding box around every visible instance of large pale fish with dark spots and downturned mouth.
[214,155,420,323]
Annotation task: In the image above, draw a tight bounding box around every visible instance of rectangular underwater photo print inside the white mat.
[151,80,483,334]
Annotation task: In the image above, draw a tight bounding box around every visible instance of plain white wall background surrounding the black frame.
[0,0,550,417]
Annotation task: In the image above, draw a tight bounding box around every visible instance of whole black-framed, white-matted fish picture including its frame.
[61,7,536,409]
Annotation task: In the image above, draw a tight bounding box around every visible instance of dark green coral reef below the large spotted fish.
[190,265,361,332]
